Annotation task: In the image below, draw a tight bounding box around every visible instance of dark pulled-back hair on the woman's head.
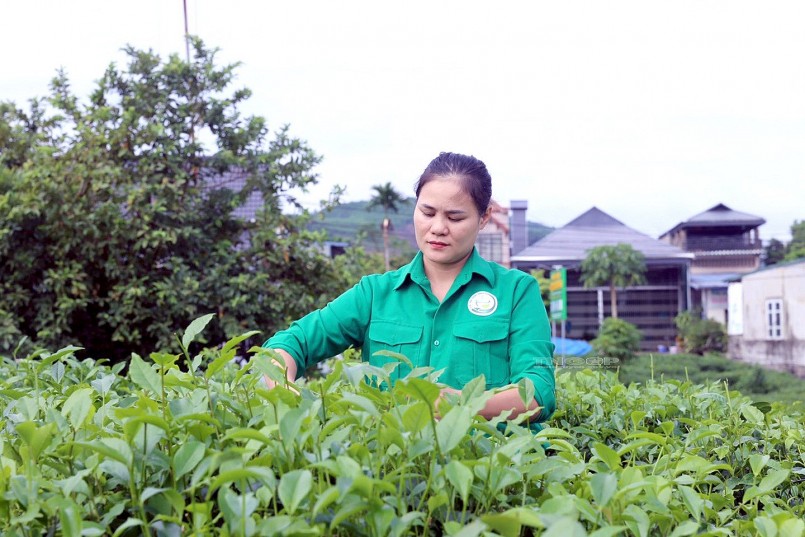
[414,153,492,214]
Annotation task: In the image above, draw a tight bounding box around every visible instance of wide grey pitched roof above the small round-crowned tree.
[512,207,693,263]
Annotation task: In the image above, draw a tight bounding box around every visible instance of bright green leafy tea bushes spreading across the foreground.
[0,319,805,537]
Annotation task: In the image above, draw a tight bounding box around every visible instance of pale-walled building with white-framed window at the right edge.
[727,258,805,377]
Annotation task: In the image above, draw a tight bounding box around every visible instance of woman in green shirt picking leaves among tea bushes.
[263,153,556,421]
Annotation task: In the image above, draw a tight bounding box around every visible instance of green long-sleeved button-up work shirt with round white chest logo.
[263,250,556,421]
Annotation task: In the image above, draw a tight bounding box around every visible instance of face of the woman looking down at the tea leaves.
[414,177,490,268]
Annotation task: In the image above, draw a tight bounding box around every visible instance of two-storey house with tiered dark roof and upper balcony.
[660,203,766,324]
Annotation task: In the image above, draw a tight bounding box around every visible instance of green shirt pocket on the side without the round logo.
[367,320,424,380]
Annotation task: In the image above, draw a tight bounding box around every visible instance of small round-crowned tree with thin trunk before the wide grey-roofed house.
[581,243,646,319]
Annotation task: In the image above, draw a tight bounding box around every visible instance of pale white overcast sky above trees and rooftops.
[0,0,805,241]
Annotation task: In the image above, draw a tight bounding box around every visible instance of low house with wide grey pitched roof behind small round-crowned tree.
[511,207,693,350]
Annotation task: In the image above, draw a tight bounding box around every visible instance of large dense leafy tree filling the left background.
[0,40,346,360]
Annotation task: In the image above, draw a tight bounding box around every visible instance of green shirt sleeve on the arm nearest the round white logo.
[509,278,556,421]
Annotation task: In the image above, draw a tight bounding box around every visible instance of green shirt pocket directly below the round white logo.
[453,319,511,389]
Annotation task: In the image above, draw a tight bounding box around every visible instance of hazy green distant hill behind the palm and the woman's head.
[308,198,553,252]
